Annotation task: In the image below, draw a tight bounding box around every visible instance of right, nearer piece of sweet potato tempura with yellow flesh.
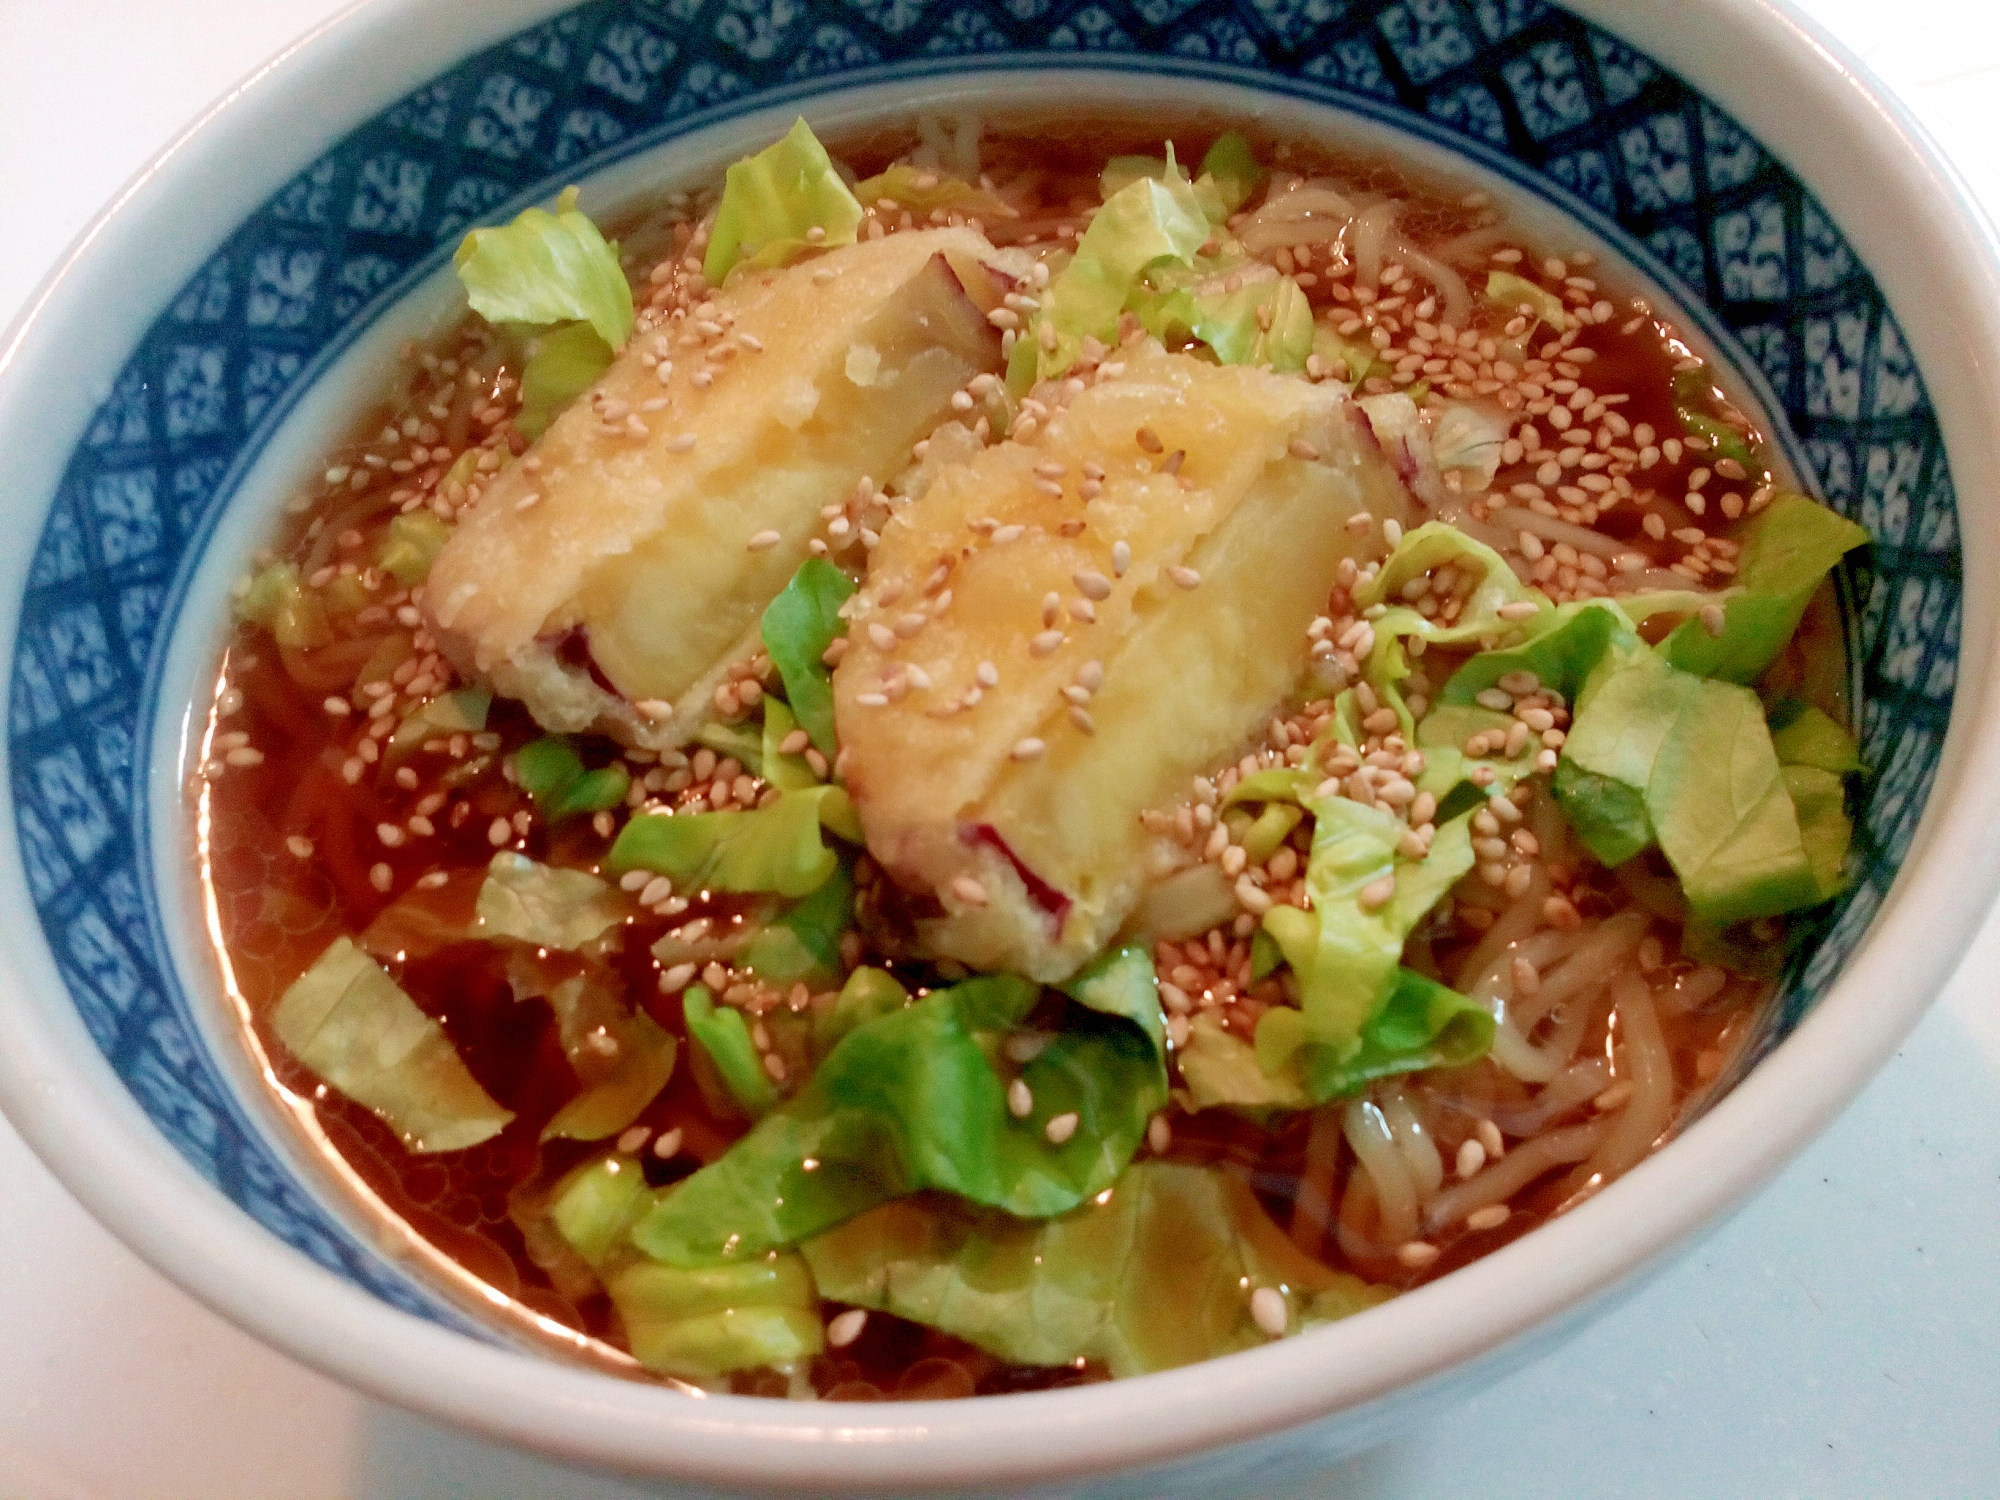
[834,350,1410,980]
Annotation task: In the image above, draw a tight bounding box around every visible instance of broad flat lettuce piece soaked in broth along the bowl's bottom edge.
[804,1162,1392,1376]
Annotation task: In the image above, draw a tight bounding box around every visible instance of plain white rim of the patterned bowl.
[0,0,2000,1492]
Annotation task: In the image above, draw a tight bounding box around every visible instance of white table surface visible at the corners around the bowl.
[0,0,2000,1500]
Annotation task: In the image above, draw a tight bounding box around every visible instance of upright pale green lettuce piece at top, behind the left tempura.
[702,116,862,286]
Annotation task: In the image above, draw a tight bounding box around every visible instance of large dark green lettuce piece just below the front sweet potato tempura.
[632,948,1166,1266]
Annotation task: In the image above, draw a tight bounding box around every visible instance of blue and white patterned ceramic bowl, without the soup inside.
[0,0,2000,1498]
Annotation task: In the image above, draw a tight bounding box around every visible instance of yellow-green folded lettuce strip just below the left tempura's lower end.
[604,786,836,898]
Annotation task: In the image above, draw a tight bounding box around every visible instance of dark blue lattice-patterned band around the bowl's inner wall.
[8,0,1960,1328]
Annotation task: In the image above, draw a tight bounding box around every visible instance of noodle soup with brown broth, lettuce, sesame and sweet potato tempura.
[196,120,1866,1400]
